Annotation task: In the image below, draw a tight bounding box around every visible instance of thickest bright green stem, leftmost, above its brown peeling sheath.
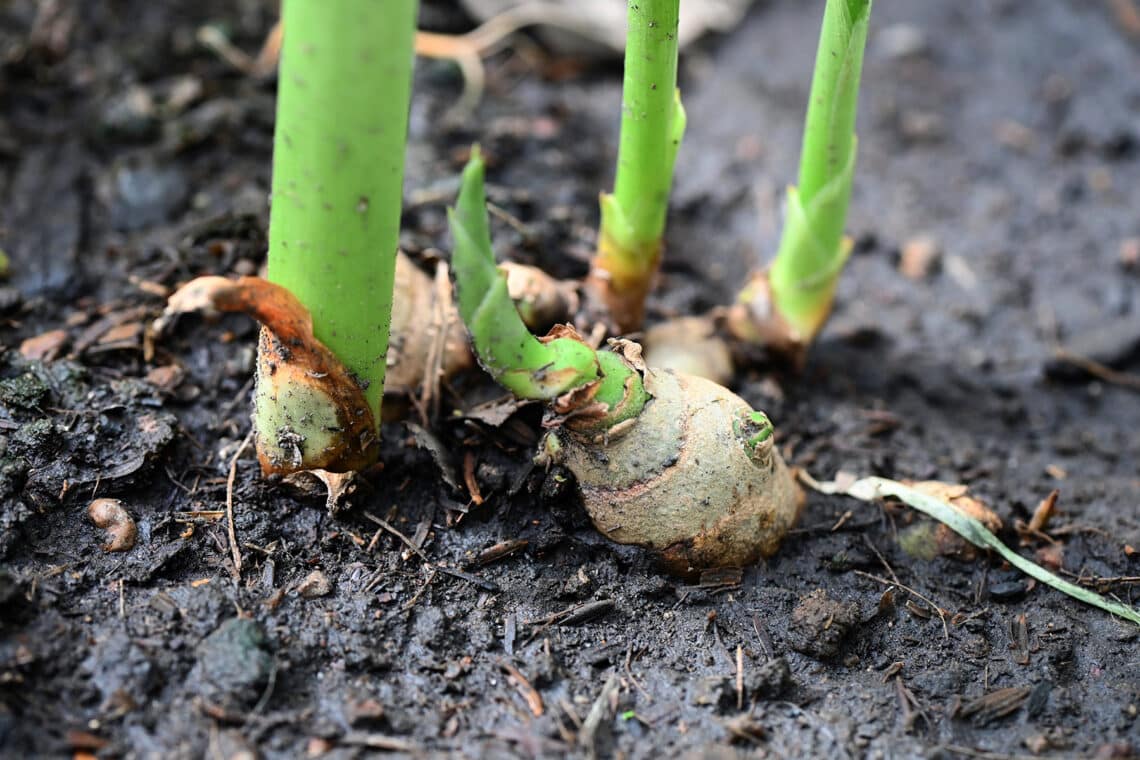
[269,0,417,424]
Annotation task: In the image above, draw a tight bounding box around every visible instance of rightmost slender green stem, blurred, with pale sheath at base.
[770,0,871,341]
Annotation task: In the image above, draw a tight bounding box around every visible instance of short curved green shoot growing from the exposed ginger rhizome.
[448,148,648,426]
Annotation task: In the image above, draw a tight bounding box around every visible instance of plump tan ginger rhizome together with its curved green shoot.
[448,149,799,574]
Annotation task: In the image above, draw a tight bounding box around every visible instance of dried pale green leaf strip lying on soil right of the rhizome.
[800,473,1140,626]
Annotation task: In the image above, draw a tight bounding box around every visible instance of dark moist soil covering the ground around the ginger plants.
[0,0,1140,758]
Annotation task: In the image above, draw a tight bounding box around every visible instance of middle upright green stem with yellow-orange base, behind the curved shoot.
[587,0,685,333]
